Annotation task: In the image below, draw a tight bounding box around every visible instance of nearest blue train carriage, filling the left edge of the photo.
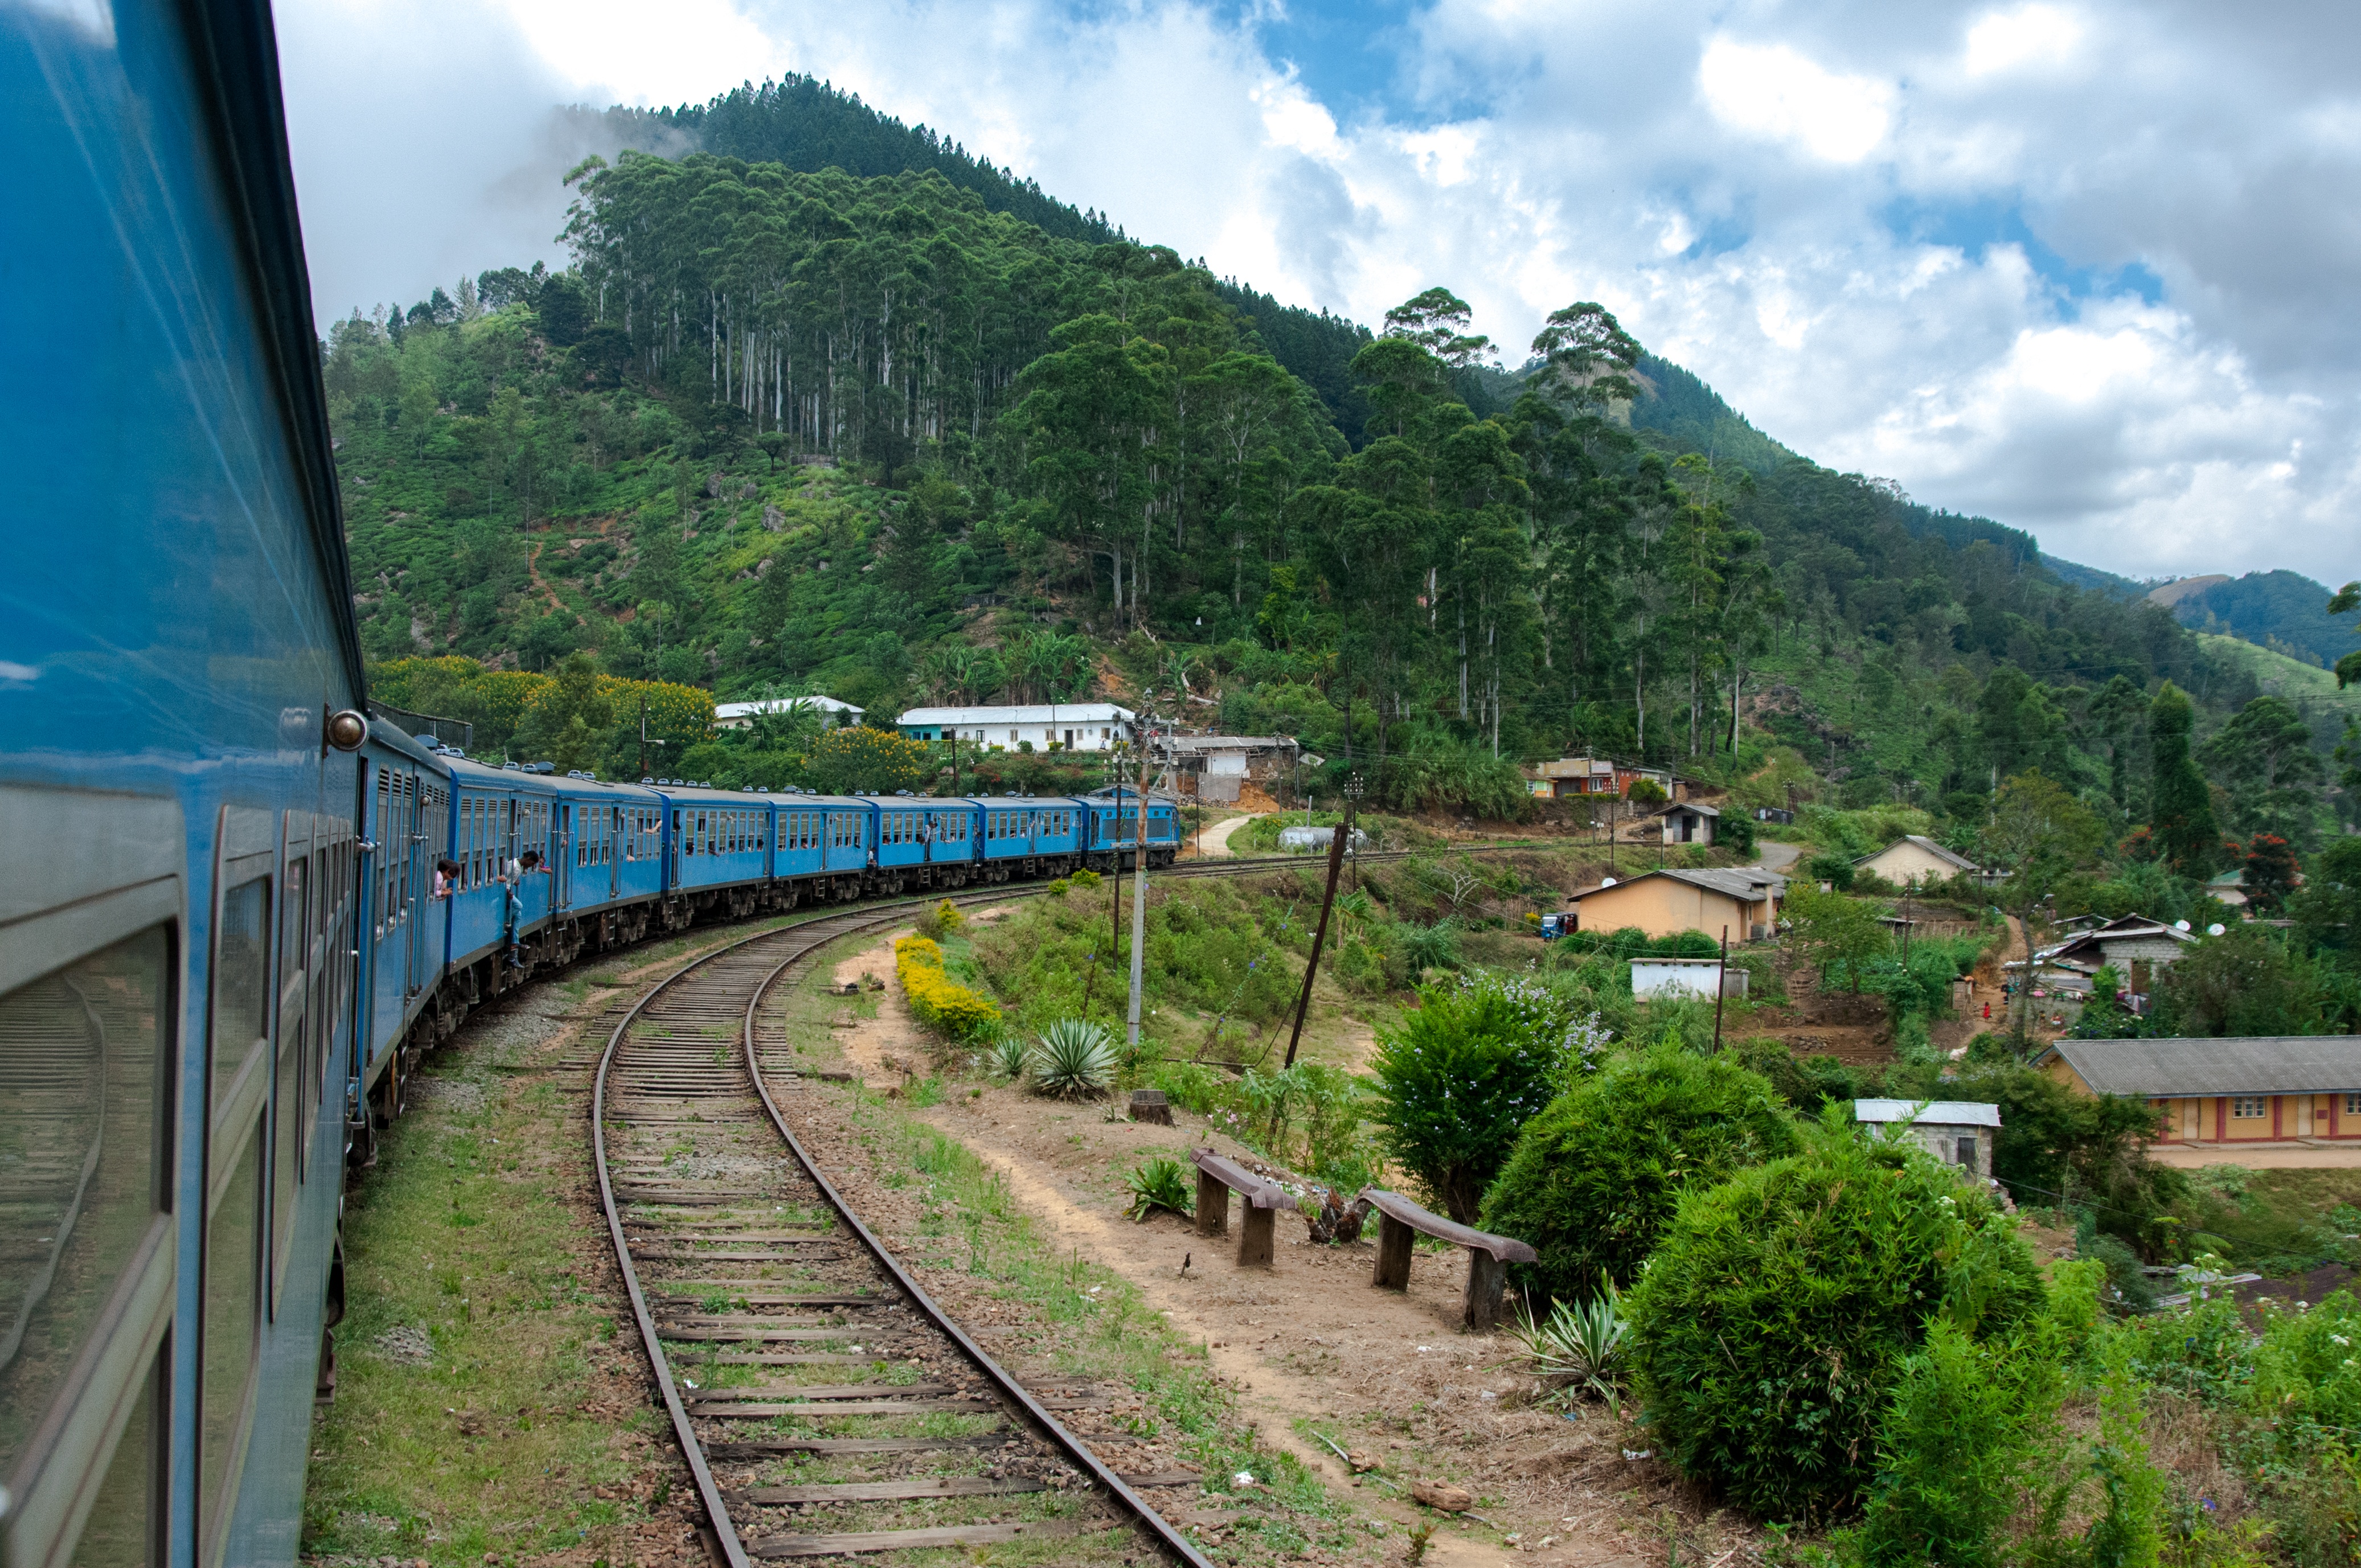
[0,0,380,1568]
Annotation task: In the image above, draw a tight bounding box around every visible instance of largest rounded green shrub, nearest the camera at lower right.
[1629,1107,2042,1518]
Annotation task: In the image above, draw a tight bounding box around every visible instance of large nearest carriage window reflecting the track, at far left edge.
[0,926,177,1476]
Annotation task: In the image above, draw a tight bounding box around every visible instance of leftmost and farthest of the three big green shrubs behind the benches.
[1370,978,1565,1223]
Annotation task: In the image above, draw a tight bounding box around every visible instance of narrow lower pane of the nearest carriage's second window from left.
[196,1122,264,1561]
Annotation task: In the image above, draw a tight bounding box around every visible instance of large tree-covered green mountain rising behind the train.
[326,83,2351,845]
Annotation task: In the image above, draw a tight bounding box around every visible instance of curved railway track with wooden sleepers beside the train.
[593,888,1209,1568]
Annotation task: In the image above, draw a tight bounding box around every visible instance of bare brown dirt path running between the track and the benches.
[793,942,1700,1568]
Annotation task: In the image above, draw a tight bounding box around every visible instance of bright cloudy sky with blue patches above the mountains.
[278,0,2361,581]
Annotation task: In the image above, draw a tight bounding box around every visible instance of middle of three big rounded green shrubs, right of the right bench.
[1483,1044,1801,1299]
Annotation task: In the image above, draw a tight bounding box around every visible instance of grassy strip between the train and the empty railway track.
[302,1011,661,1566]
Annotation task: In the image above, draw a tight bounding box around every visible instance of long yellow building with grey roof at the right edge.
[2033,1035,2361,1167]
